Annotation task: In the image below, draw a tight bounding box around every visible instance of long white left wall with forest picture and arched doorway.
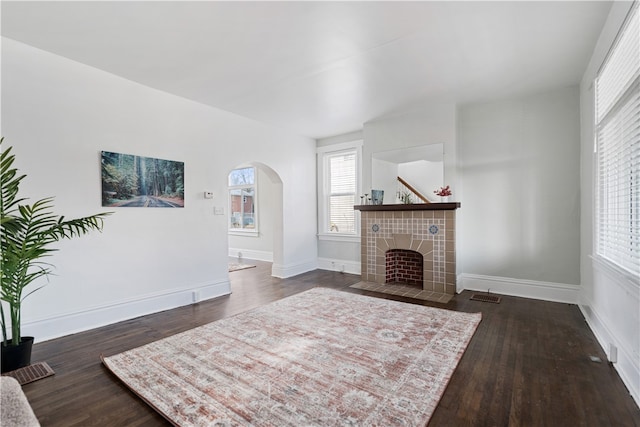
[2,38,317,340]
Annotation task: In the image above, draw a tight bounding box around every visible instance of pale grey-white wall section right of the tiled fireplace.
[457,87,580,300]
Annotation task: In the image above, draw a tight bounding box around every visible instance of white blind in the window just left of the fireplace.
[327,151,357,233]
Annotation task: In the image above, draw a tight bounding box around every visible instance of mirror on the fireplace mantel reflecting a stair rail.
[371,144,444,204]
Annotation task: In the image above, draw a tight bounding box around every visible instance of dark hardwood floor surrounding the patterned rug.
[24,262,640,427]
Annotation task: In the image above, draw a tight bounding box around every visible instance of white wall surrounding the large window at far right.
[580,2,640,404]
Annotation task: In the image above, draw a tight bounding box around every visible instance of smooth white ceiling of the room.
[1,1,611,138]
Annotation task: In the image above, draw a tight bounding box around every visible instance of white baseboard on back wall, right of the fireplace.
[456,273,580,304]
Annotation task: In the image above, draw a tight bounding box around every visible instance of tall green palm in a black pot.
[0,138,110,372]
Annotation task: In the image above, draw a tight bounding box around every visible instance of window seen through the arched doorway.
[229,167,258,232]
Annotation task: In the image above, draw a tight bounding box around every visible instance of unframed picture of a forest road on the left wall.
[102,151,184,208]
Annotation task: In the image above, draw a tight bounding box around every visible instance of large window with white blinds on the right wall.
[595,2,640,277]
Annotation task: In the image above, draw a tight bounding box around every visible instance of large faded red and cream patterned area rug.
[102,288,481,426]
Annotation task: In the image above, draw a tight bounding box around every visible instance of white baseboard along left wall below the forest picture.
[22,280,231,342]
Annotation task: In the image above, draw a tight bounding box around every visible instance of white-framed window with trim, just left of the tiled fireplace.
[318,142,362,237]
